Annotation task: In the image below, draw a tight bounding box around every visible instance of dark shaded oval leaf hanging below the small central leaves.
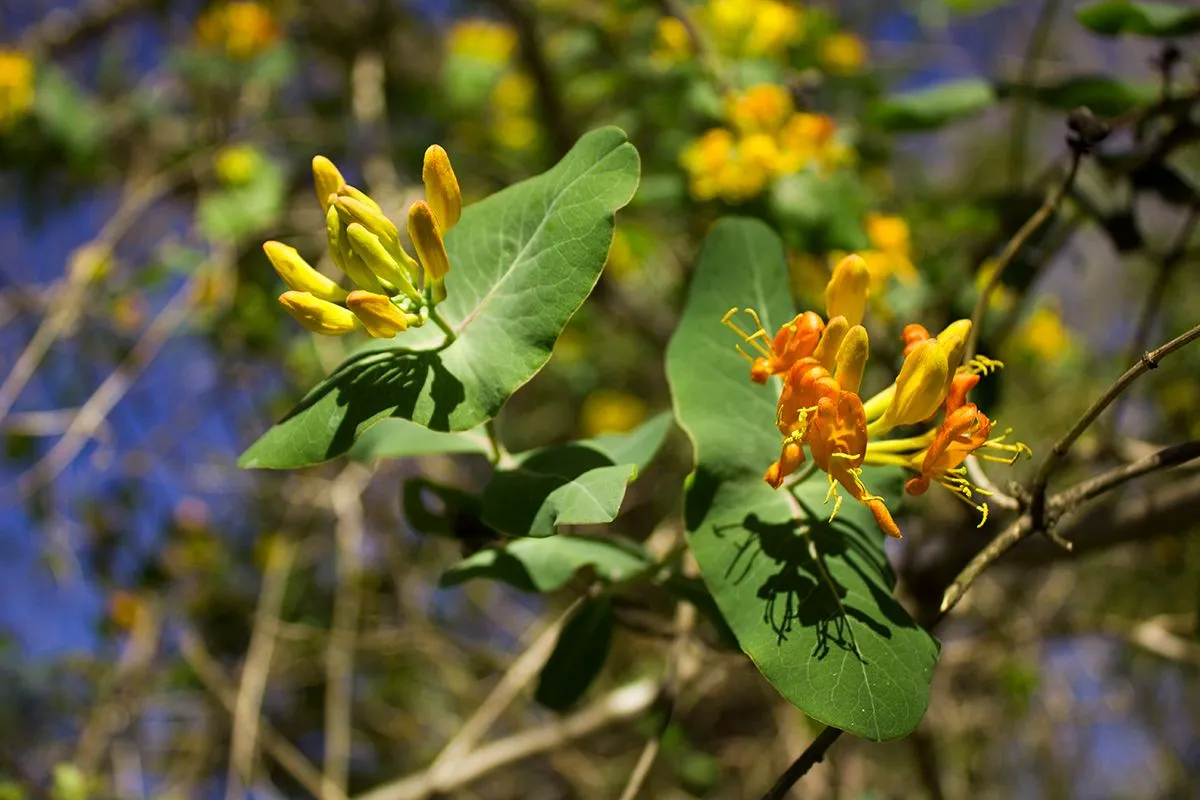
[534,596,616,711]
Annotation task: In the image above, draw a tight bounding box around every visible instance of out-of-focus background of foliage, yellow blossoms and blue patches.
[0,0,1200,800]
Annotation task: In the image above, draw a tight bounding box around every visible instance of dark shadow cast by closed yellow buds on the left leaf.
[282,349,467,457]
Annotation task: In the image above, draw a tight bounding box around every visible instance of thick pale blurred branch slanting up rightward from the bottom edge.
[355,679,659,800]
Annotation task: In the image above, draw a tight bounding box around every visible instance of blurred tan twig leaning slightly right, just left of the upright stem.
[226,539,295,800]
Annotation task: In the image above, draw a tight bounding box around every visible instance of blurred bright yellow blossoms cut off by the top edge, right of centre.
[650,0,805,66]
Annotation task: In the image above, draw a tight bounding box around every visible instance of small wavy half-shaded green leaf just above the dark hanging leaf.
[442,536,654,593]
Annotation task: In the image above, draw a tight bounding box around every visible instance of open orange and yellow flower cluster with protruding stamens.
[722,254,1031,539]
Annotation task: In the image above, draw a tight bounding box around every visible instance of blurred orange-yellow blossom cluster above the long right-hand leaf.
[680,84,853,203]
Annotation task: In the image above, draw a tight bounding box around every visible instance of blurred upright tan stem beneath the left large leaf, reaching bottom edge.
[320,464,371,800]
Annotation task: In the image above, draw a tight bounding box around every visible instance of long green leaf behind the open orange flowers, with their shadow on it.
[667,219,937,740]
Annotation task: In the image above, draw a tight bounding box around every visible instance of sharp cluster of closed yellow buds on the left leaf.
[263,145,462,338]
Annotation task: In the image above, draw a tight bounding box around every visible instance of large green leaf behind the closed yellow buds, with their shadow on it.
[239,127,638,469]
